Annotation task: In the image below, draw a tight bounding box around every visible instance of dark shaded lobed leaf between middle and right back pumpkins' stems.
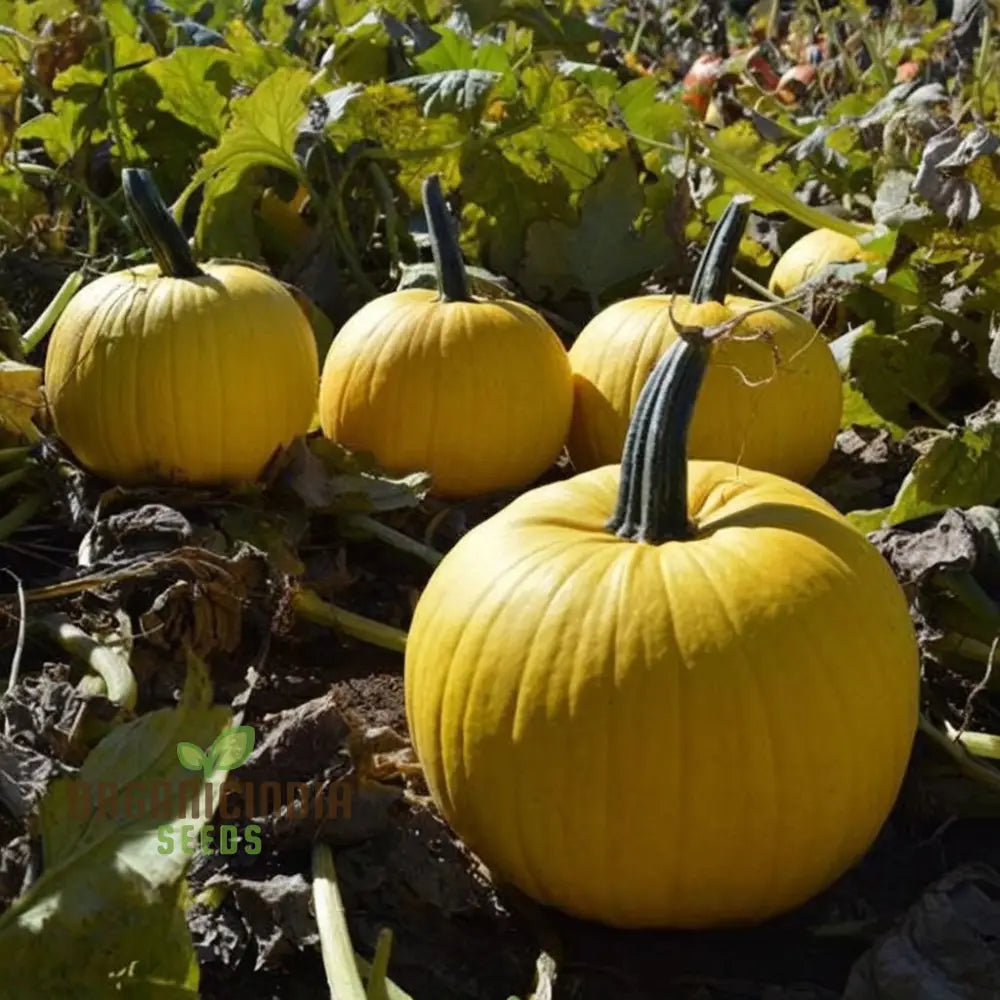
[521,156,682,299]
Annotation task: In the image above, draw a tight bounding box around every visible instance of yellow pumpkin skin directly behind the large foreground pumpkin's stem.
[569,295,843,482]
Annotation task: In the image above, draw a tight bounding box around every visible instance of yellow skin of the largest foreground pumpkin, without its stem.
[405,462,918,928]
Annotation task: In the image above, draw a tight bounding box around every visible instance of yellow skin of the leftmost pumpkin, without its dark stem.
[45,264,319,484]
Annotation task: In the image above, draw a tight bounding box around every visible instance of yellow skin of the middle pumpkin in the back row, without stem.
[319,289,573,497]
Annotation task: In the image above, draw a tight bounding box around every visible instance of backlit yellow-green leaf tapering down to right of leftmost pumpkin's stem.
[174,69,311,216]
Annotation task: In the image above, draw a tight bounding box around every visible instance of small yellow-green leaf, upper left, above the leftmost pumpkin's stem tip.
[143,46,233,139]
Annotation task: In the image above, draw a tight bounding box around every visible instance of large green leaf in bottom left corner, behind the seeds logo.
[0,657,230,1000]
